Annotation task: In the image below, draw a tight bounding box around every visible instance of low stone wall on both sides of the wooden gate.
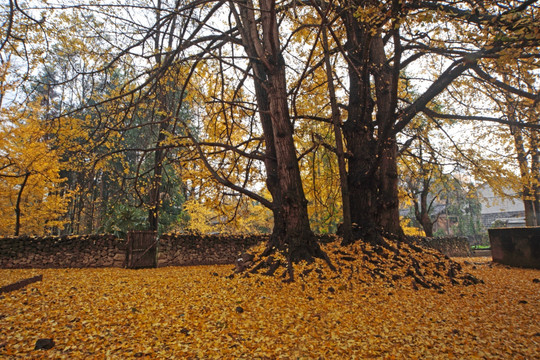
[0,234,267,269]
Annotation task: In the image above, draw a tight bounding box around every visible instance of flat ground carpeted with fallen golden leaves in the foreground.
[0,253,540,359]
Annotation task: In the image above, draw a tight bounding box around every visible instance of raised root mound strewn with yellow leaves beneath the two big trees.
[235,237,483,292]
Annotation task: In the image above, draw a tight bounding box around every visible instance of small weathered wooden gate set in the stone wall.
[126,231,159,269]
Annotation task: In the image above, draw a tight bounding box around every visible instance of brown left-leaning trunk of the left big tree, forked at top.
[235,0,324,264]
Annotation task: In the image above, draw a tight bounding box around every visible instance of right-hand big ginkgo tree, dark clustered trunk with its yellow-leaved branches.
[302,1,538,242]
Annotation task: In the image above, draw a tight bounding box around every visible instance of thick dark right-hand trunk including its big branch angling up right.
[340,2,475,239]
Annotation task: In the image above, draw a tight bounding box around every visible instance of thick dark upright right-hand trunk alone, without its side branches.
[344,14,401,240]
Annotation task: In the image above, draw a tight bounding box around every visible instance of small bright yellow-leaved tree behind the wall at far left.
[0,102,69,236]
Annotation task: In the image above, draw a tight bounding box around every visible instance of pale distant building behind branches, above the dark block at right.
[477,184,525,228]
